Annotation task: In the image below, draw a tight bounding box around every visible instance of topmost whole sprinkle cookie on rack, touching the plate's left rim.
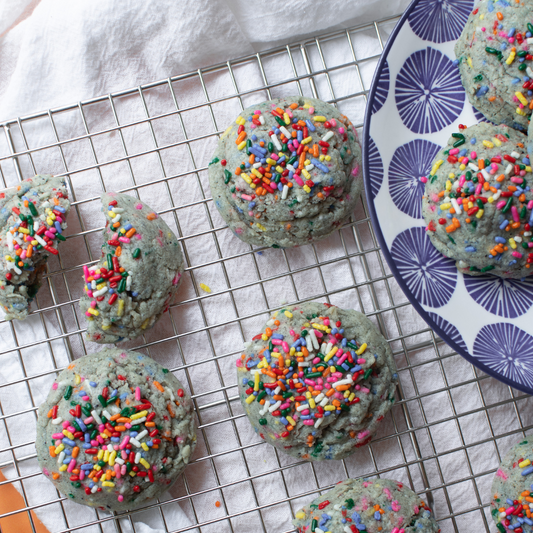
[209,96,363,248]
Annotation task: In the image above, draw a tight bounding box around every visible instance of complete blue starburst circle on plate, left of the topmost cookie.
[395,46,465,133]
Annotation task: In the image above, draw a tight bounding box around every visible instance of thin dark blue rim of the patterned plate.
[363,0,533,395]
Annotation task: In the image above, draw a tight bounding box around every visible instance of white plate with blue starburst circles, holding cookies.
[363,0,533,394]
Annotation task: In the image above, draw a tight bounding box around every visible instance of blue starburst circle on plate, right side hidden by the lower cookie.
[389,139,440,218]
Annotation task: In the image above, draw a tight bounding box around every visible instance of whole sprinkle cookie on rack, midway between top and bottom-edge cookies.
[237,302,398,461]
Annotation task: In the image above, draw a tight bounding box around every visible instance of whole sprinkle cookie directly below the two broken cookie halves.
[35,348,196,511]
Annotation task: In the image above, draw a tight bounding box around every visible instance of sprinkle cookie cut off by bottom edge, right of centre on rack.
[292,479,440,533]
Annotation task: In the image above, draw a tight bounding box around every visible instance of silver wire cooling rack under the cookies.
[0,11,532,533]
